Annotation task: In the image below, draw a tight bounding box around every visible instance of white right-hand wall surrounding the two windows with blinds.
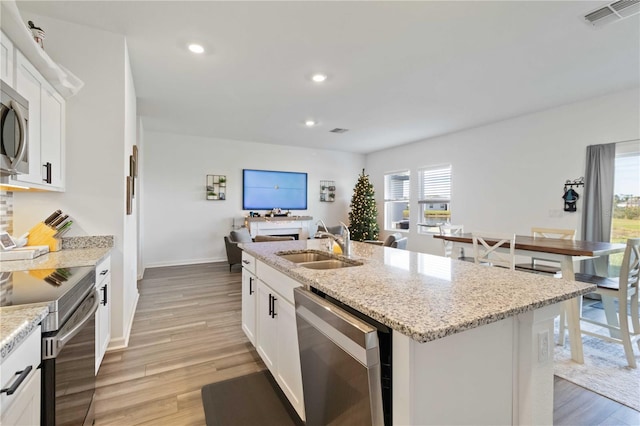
[366,88,640,254]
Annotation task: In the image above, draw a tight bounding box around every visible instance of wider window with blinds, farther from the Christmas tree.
[418,164,451,234]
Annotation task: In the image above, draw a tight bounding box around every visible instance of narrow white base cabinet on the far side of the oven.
[96,256,111,374]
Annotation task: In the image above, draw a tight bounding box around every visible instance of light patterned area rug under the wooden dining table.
[553,324,640,411]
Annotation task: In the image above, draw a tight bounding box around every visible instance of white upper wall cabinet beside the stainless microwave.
[10,50,65,191]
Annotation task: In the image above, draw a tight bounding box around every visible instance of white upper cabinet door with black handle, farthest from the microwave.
[40,83,65,189]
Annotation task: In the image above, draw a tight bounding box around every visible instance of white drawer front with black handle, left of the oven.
[0,327,42,413]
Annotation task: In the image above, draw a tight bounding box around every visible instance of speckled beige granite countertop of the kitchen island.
[242,240,595,342]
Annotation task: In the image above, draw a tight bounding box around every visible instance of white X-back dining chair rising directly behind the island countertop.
[471,232,516,270]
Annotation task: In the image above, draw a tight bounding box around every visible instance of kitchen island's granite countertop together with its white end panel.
[242,240,594,424]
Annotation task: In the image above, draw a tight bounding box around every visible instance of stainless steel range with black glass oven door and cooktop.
[0,267,100,426]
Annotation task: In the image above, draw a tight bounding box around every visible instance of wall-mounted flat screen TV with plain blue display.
[242,169,307,210]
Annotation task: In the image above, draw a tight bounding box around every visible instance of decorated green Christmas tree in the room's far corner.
[349,169,380,241]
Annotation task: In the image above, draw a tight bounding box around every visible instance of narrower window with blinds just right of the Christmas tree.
[384,170,410,231]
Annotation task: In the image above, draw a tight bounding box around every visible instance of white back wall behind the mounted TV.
[142,131,364,267]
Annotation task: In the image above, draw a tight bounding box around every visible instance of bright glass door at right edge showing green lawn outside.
[609,141,640,277]
